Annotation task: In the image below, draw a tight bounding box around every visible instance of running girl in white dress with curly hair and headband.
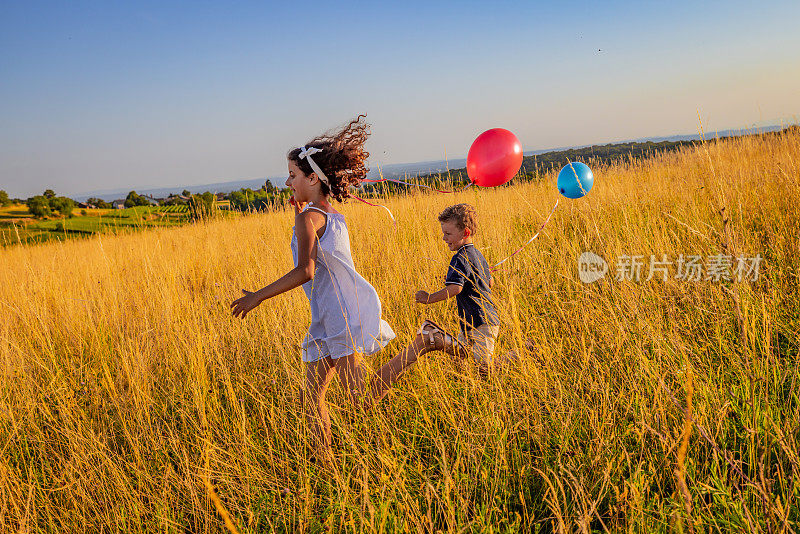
[231,115,453,452]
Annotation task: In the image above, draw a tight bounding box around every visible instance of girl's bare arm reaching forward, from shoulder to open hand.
[231,211,325,319]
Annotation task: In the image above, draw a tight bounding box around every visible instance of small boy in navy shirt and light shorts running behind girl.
[415,204,500,376]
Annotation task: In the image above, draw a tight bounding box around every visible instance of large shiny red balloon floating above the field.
[467,128,522,187]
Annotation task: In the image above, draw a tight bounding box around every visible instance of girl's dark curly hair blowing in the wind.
[286,115,370,202]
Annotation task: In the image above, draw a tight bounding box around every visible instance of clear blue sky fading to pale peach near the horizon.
[0,0,800,198]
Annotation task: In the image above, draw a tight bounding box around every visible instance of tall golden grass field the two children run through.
[0,129,800,533]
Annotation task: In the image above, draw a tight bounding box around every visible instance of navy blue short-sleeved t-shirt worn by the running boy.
[444,243,500,332]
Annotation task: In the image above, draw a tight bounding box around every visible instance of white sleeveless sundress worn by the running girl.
[292,206,395,362]
